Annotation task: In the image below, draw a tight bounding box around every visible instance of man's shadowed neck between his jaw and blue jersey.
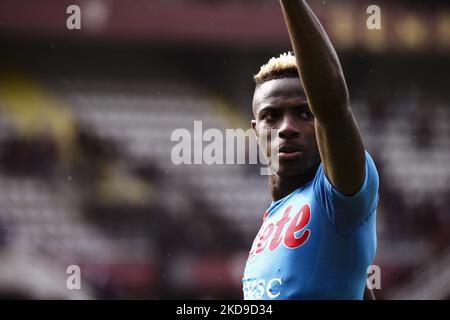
[269,167,317,201]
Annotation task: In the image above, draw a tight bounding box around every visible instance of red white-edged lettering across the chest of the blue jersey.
[249,204,311,258]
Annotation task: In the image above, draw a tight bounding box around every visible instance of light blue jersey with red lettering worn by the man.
[242,152,378,299]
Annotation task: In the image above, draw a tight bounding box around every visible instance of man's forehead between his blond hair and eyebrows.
[253,78,306,109]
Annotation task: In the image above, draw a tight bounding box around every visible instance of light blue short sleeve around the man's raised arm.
[313,151,379,235]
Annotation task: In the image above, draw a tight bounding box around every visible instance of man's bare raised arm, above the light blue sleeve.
[279,0,365,195]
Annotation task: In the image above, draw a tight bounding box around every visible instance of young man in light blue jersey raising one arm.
[242,0,378,299]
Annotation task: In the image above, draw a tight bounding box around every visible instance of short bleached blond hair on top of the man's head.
[253,51,299,86]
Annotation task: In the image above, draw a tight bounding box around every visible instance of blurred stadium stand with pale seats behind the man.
[0,0,450,299]
